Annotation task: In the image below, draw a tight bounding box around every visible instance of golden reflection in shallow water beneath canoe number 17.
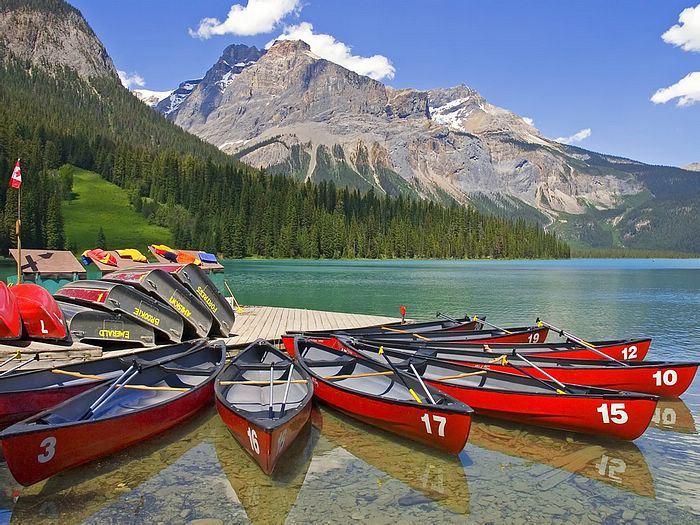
[313,406,469,514]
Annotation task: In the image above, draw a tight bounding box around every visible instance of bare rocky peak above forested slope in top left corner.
[0,0,117,80]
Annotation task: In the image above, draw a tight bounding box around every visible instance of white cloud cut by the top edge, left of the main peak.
[189,0,301,39]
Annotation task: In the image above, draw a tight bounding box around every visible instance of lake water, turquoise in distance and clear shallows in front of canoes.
[0,259,700,524]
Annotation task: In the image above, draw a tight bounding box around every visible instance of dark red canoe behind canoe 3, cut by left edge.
[0,343,209,428]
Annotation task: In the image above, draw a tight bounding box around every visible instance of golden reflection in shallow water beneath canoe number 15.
[469,418,655,497]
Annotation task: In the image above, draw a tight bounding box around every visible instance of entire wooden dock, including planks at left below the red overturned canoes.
[0,306,401,371]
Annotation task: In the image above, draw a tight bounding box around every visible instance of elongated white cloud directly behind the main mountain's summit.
[265,22,396,80]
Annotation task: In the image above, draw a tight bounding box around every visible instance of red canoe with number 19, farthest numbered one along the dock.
[282,326,549,356]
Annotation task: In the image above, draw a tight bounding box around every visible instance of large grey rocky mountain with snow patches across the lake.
[152,41,700,250]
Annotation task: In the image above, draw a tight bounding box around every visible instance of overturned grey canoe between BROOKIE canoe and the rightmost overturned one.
[102,266,214,337]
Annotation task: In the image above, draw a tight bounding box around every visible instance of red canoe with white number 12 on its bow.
[306,336,651,361]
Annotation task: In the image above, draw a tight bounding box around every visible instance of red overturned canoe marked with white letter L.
[10,283,68,341]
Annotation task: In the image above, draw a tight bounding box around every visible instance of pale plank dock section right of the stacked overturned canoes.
[225,306,401,346]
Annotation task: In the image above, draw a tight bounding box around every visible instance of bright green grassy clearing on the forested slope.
[61,168,173,254]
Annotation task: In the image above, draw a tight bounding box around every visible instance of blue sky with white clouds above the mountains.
[69,0,700,166]
